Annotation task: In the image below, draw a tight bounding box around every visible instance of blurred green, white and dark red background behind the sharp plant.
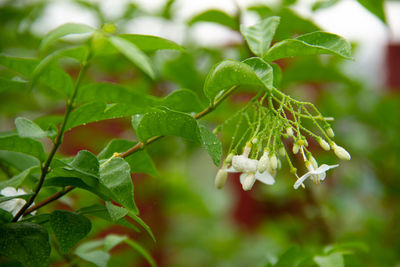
[0,0,400,266]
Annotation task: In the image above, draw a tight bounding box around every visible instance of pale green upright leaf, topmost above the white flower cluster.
[240,16,280,57]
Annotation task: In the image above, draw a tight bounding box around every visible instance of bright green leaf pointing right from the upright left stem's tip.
[118,34,184,52]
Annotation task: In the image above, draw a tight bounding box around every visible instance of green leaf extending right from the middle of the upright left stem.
[65,102,148,131]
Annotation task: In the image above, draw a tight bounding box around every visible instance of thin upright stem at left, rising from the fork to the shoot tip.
[12,57,90,222]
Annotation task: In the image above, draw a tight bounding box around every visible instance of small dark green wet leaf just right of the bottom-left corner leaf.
[50,210,92,254]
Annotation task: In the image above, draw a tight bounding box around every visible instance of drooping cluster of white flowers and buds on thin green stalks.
[215,89,351,191]
